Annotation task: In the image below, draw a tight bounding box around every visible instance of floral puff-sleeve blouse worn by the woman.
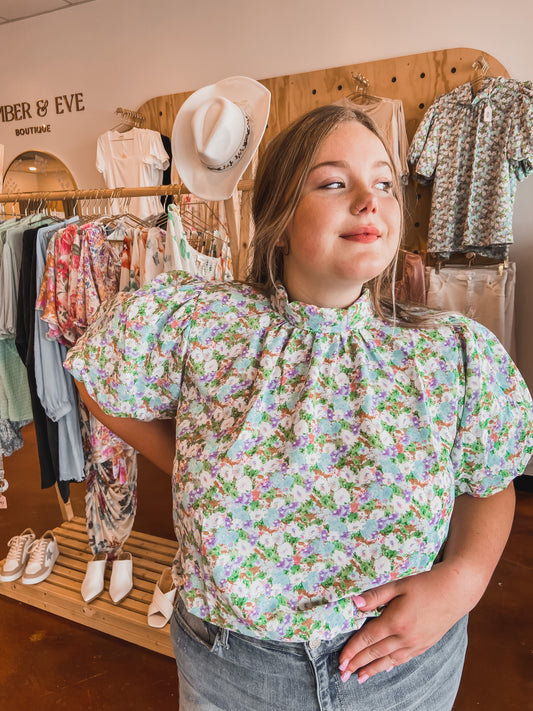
[66,272,533,641]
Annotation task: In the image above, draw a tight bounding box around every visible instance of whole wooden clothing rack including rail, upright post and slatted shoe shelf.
[0,181,253,657]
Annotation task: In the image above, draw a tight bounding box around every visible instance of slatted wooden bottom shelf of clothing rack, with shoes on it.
[0,517,177,657]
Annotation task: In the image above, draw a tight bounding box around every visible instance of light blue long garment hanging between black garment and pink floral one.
[34,218,85,481]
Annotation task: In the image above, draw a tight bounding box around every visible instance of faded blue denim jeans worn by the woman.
[171,599,467,711]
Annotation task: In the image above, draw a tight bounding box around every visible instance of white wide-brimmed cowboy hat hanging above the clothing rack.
[172,77,270,200]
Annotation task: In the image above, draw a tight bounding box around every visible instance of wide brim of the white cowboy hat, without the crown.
[172,76,270,200]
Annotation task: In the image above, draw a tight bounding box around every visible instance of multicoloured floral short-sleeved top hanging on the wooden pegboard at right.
[408,77,533,257]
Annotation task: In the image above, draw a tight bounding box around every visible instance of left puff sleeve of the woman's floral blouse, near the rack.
[65,272,205,420]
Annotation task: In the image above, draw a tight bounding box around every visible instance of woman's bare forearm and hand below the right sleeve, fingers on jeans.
[339,484,515,683]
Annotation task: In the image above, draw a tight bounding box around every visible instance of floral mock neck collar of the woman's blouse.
[270,283,373,333]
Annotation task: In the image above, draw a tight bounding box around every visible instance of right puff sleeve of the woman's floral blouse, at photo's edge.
[451,318,533,497]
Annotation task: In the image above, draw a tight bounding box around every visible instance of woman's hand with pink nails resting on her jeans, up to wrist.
[339,562,475,683]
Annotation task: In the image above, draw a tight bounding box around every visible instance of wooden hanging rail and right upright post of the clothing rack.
[0,184,254,276]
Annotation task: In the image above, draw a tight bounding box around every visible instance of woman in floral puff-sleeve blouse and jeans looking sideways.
[67,106,532,711]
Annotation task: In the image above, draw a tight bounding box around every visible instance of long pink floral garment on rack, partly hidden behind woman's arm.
[37,223,137,557]
